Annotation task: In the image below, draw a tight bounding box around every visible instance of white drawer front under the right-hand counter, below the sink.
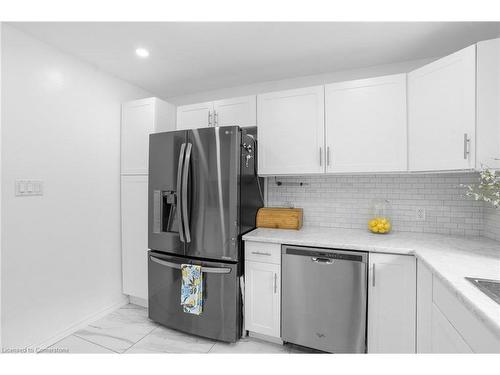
[432,276,500,353]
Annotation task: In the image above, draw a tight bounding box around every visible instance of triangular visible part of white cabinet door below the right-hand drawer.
[432,304,472,353]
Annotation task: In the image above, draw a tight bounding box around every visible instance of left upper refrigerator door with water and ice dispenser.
[148,131,186,255]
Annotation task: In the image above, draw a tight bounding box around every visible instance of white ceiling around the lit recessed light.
[11,22,500,98]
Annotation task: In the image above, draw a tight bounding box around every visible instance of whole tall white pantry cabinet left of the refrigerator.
[121,98,176,304]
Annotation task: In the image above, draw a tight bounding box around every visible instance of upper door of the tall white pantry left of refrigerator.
[121,98,155,174]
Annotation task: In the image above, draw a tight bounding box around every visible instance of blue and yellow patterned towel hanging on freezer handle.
[181,264,203,315]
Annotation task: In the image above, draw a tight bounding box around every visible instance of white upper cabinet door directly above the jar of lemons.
[325,74,407,172]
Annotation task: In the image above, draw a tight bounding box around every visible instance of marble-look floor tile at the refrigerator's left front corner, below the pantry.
[75,305,158,353]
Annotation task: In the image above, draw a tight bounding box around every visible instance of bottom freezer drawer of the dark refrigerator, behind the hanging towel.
[148,251,241,342]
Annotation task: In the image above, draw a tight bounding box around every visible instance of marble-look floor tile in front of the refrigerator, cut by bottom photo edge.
[126,326,215,353]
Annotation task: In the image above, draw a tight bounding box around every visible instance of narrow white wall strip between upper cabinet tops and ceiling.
[165,59,433,105]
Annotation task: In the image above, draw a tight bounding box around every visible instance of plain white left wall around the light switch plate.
[1,25,151,348]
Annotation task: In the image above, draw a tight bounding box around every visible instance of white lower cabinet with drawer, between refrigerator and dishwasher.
[245,242,281,339]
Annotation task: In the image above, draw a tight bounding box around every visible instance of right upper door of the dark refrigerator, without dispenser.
[183,126,241,261]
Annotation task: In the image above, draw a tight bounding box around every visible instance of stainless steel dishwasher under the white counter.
[281,245,368,353]
